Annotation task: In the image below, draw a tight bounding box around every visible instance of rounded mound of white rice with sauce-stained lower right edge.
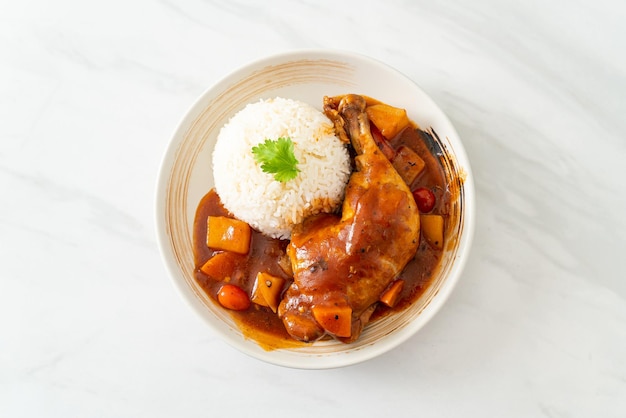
[213,97,350,239]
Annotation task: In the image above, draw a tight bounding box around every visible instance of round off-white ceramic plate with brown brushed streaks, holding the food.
[156,50,474,369]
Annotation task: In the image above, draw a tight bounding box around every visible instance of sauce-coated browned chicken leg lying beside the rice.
[278,95,420,342]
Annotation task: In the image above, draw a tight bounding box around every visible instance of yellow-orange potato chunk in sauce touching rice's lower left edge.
[207,216,251,254]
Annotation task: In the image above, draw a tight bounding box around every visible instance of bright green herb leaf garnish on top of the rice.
[252,137,300,182]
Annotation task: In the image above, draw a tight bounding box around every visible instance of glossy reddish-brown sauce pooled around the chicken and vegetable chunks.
[193,128,449,348]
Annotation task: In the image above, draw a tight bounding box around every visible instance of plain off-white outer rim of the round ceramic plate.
[154,49,475,369]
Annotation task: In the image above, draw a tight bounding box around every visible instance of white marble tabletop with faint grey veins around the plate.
[0,0,626,417]
